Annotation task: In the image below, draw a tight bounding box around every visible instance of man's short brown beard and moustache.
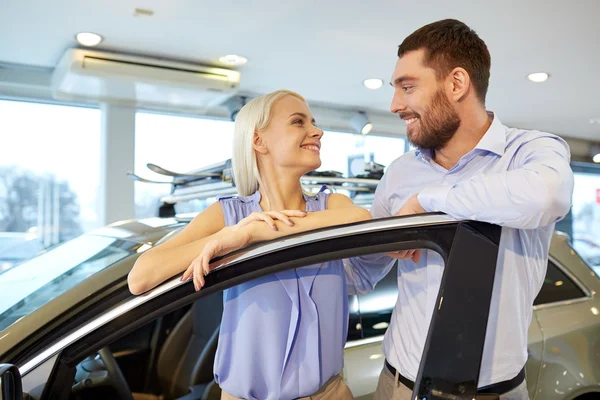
[400,90,460,150]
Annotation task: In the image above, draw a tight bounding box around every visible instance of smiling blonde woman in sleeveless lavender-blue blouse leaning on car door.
[128,90,370,400]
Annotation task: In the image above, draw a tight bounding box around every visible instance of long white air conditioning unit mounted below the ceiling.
[52,49,240,109]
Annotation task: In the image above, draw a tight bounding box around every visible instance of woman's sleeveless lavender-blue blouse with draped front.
[214,192,348,400]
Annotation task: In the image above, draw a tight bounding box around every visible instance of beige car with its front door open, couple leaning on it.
[0,213,600,400]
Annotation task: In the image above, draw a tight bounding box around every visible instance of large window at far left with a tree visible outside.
[0,100,100,273]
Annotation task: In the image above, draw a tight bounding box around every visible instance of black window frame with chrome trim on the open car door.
[14,213,500,398]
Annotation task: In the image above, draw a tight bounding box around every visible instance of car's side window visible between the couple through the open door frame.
[358,264,398,339]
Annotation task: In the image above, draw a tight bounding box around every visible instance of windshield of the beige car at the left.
[0,235,137,331]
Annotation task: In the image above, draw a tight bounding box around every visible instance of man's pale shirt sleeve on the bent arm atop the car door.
[418,136,573,229]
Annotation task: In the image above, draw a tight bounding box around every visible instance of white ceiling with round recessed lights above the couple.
[0,0,600,140]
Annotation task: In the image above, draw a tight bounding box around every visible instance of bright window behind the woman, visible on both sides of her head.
[135,112,405,218]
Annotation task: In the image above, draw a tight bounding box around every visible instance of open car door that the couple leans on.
[14,213,501,399]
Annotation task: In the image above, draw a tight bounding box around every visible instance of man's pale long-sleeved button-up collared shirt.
[346,114,573,387]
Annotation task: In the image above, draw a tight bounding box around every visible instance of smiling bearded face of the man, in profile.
[390,50,460,150]
